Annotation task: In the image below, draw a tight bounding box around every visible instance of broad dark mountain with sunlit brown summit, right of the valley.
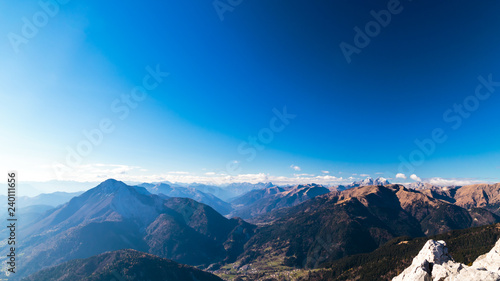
[238,185,500,268]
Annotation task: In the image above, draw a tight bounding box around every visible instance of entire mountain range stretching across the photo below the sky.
[6,179,500,280]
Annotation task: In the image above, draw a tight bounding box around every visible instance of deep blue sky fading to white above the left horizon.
[0,0,500,188]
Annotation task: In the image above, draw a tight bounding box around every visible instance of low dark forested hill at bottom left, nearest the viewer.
[23,249,222,281]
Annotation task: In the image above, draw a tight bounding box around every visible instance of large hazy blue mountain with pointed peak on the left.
[4,180,255,276]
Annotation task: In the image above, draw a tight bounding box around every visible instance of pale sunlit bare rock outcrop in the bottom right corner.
[392,237,500,281]
